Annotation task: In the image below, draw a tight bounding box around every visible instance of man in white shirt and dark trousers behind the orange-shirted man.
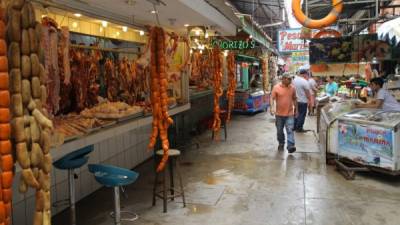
[293,69,310,133]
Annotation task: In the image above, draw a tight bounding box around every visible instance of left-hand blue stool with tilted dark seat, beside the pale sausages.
[53,145,93,225]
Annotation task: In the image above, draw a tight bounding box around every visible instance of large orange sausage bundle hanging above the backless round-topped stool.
[148,27,173,172]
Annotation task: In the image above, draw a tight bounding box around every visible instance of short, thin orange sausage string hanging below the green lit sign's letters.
[226,52,236,122]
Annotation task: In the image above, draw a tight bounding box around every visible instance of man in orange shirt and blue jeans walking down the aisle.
[270,73,297,153]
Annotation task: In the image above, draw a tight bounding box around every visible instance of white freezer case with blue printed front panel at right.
[337,109,400,175]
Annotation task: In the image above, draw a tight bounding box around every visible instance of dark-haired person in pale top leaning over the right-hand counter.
[356,77,400,112]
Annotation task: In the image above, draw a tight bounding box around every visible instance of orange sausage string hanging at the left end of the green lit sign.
[212,48,223,140]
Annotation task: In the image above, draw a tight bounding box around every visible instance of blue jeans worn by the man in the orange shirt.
[275,116,294,148]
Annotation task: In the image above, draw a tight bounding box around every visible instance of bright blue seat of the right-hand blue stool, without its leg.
[88,164,139,187]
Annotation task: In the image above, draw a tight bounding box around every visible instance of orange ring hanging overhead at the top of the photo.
[292,0,343,29]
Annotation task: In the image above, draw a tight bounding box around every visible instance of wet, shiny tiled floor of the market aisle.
[53,113,400,225]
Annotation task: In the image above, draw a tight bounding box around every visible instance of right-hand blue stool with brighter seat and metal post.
[89,164,139,225]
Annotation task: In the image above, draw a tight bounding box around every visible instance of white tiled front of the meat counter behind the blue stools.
[13,104,190,225]
